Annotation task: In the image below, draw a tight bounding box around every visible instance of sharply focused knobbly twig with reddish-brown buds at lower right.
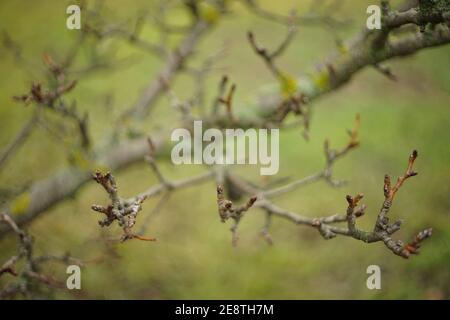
[217,151,432,258]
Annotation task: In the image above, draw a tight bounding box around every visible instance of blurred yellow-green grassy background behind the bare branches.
[0,0,450,299]
